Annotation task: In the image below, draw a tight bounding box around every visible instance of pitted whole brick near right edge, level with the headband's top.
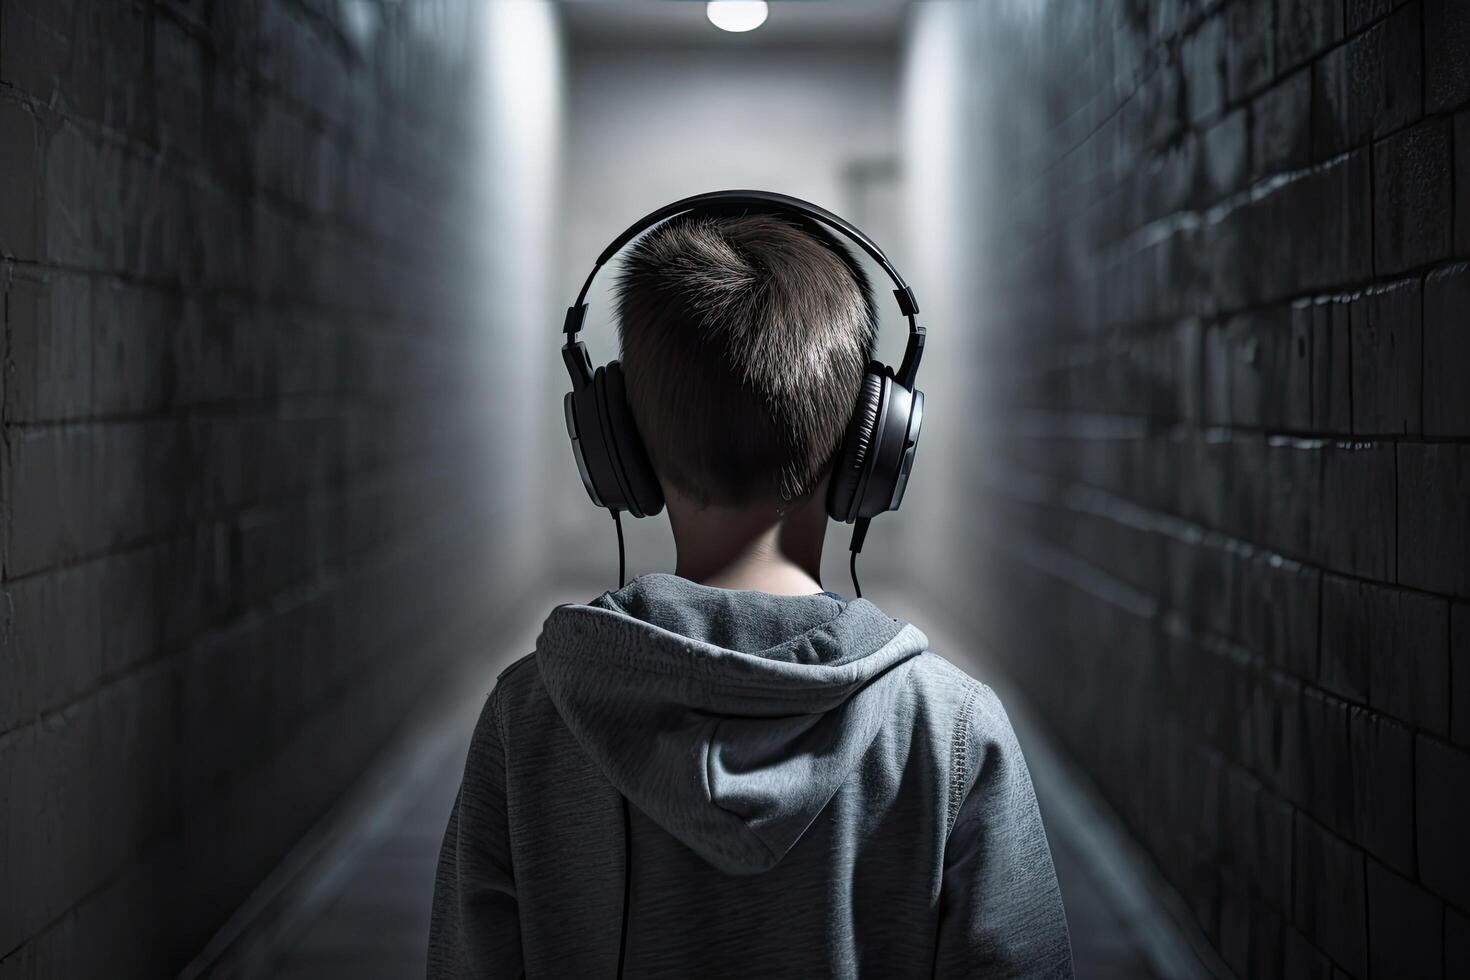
[1373,119,1454,273]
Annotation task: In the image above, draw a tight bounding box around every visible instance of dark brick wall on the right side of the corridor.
[973,0,1470,979]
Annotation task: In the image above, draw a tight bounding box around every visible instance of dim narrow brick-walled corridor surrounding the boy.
[0,0,1470,980]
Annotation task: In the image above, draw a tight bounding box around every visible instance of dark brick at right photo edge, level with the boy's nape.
[1398,444,1470,597]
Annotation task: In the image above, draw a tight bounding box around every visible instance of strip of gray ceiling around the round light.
[559,0,908,47]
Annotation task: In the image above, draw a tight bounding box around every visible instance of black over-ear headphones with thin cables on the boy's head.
[562,191,925,595]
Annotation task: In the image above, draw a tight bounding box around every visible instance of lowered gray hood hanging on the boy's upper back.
[537,574,928,874]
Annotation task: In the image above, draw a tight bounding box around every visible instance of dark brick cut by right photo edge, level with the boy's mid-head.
[1423,262,1470,435]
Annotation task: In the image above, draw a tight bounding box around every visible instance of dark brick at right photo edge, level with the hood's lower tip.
[1414,735,1470,908]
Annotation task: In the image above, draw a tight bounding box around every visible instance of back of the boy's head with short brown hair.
[617,213,878,507]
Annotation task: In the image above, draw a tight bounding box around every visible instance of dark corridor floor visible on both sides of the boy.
[201,586,1220,980]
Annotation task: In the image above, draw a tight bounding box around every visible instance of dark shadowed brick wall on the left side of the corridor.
[0,0,511,979]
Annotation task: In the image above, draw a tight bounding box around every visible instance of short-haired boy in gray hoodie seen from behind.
[429,213,1072,977]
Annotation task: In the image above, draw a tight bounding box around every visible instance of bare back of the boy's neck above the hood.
[669,484,826,595]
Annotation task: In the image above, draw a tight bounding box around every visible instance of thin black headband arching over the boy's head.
[562,191,925,388]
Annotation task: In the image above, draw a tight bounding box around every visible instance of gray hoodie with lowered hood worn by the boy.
[429,574,1072,977]
